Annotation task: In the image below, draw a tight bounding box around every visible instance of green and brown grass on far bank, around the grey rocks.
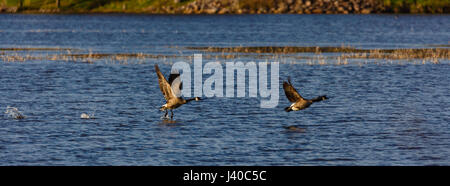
[0,0,450,13]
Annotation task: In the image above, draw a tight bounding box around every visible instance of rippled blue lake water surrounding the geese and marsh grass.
[0,14,450,165]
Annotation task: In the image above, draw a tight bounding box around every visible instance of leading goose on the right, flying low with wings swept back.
[283,77,328,112]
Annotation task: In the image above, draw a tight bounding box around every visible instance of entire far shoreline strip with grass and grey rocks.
[0,0,450,14]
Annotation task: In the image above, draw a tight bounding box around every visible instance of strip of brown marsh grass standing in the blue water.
[0,46,450,65]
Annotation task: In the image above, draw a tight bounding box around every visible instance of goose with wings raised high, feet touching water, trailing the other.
[155,64,200,119]
